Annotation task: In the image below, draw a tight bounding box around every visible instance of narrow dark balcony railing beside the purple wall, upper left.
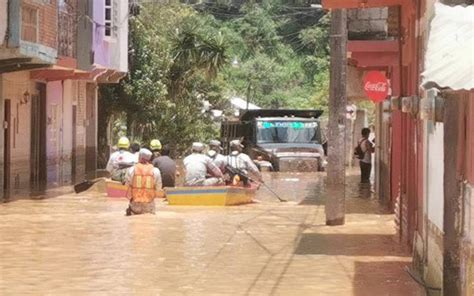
[58,11,77,58]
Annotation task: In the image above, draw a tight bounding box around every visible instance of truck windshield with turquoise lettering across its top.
[257,121,320,144]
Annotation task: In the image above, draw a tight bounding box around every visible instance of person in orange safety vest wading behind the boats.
[126,149,161,216]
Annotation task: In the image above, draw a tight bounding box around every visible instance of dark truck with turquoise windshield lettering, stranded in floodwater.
[221,109,325,172]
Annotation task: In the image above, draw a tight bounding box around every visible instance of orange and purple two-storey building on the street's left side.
[0,0,128,199]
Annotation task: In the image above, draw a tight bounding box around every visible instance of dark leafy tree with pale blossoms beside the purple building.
[101,4,227,157]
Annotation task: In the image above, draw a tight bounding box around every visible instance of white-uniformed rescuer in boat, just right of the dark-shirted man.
[183,142,224,186]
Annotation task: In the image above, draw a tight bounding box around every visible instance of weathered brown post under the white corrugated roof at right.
[441,0,472,296]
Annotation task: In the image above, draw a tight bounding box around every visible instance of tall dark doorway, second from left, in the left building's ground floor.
[30,83,47,190]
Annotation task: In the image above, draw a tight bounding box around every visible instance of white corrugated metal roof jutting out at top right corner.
[421,3,474,90]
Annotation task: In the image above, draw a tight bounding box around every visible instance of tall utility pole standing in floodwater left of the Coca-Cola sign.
[325,9,347,225]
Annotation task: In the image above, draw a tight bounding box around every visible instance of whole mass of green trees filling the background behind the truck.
[99,0,329,162]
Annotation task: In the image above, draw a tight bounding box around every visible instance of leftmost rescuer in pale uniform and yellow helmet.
[105,137,136,183]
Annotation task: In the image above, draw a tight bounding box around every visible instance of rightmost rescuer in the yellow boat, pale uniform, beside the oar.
[227,140,263,185]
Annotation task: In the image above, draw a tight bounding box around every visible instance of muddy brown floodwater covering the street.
[0,173,421,296]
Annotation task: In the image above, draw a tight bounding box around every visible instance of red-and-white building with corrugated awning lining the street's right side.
[323,0,474,295]
